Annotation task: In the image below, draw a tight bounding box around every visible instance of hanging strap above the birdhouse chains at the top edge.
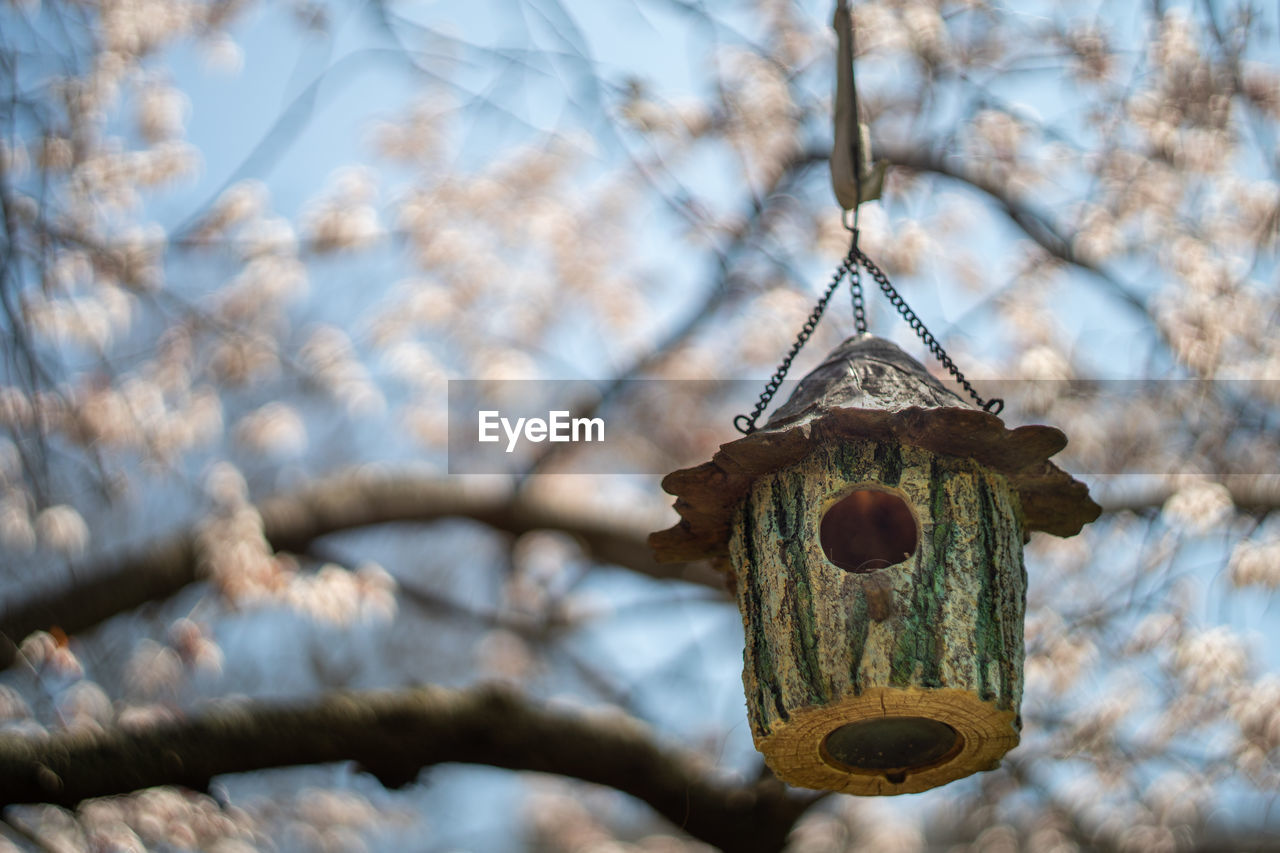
[831,0,886,210]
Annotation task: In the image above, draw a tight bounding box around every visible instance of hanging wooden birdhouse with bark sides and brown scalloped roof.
[650,334,1101,794]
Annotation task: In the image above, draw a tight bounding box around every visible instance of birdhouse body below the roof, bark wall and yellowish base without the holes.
[730,441,1027,794]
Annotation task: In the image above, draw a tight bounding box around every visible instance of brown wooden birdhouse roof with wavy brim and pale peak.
[649,334,1102,562]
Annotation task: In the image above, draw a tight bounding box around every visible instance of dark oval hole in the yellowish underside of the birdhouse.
[822,717,964,784]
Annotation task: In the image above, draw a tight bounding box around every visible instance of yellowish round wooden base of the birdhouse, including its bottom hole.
[755,688,1020,795]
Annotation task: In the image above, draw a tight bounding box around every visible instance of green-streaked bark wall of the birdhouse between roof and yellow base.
[730,441,1025,736]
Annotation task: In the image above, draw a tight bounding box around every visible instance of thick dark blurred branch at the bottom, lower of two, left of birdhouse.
[0,686,810,852]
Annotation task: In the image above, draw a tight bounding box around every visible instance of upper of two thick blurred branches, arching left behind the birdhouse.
[0,474,723,666]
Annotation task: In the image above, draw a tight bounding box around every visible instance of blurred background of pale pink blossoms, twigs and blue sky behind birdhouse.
[0,0,1280,853]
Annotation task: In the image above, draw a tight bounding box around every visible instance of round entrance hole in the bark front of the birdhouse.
[818,489,919,573]
